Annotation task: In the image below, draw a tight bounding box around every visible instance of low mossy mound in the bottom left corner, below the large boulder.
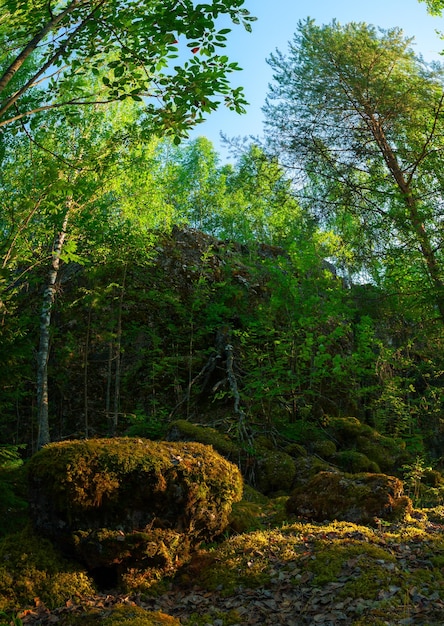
[0,529,95,610]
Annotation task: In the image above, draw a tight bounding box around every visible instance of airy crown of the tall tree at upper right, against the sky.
[264,20,444,320]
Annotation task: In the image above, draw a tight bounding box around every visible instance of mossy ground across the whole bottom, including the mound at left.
[0,498,444,626]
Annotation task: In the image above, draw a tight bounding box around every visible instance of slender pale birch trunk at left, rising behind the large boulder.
[37,207,72,450]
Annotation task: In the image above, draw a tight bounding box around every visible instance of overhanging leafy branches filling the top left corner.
[0,0,255,135]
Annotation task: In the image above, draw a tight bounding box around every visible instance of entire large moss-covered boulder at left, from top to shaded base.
[29,438,243,570]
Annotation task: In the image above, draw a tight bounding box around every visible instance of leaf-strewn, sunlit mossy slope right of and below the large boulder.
[15,507,444,626]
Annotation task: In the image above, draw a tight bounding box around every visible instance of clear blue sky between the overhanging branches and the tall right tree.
[187,0,444,159]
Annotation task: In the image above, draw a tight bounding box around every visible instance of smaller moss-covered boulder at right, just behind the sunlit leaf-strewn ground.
[287,472,412,524]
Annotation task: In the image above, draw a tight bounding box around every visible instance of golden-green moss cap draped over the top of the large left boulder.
[29,438,242,528]
